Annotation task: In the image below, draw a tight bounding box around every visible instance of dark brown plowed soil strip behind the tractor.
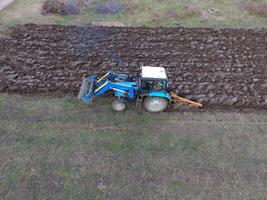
[0,24,267,109]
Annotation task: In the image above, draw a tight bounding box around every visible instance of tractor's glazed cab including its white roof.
[138,66,168,94]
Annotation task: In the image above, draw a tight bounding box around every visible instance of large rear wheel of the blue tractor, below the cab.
[144,97,168,113]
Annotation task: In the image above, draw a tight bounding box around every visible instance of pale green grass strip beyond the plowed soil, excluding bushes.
[0,0,267,28]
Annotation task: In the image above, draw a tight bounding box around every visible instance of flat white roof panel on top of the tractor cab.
[141,66,167,79]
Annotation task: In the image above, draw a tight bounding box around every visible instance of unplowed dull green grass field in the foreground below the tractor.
[0,94,267,200]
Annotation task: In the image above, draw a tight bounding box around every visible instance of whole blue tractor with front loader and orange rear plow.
[78,66,202,113]
